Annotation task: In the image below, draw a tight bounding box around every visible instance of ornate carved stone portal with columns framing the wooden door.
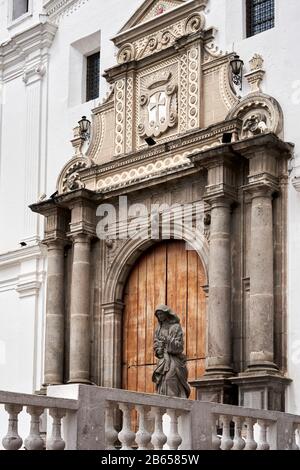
[31,0,293,411]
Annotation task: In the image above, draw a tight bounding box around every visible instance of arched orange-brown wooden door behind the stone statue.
[122,240,206,398]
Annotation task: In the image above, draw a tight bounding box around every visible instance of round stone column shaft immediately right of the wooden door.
[206,197,232,376]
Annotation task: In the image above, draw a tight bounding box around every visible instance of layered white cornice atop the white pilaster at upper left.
[0,21,57,81]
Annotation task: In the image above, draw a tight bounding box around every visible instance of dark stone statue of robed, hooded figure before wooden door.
[152,305,190,398]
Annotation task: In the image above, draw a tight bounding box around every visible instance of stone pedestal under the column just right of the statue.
[189,374,238,405]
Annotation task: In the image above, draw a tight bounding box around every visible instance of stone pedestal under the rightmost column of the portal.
[231,368,292,412]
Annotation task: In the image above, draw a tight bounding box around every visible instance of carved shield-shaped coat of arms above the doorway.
[138,72,178,137]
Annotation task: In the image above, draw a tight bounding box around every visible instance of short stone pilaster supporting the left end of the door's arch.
[103,302,124,388]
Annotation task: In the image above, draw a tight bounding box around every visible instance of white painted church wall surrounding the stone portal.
[0,0,300,414]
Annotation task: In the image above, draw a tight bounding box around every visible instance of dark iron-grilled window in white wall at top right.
[246,0,275,37]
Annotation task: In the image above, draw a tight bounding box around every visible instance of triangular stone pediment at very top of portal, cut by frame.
[120,0,185,33]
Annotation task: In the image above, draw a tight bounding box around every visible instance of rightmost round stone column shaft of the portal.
[248,187,277,370]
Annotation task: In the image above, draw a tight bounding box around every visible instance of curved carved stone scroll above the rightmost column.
[227,93,283,139]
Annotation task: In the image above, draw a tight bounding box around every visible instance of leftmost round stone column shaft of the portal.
[44,240,65,385]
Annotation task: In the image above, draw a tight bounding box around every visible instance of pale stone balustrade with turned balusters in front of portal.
[0,385,300,451]
